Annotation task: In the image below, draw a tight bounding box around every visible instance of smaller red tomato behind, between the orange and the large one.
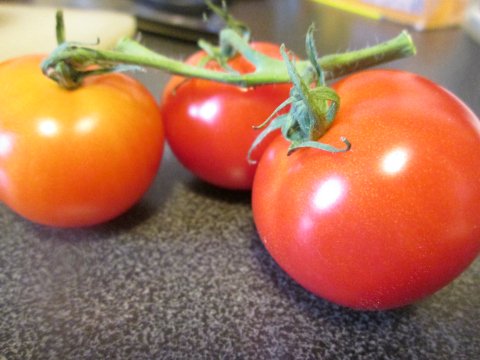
[161,43,290,190]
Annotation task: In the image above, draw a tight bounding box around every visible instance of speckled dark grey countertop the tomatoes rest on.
[0,0,480,360]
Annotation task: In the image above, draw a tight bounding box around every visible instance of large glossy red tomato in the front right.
[252,70,480,310]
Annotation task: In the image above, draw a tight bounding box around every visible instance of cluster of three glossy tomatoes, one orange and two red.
[0,43,480,309]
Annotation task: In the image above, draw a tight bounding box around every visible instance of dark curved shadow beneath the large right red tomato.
[250,234,416,332]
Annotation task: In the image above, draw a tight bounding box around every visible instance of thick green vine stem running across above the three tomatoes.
[42,29,415,88]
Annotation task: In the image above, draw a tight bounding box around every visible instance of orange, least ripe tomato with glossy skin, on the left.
[0,56,164,227]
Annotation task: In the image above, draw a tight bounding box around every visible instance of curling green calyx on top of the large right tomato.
[248,25,351,163]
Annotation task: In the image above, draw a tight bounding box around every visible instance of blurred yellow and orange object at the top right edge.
[313,0,468,30]
